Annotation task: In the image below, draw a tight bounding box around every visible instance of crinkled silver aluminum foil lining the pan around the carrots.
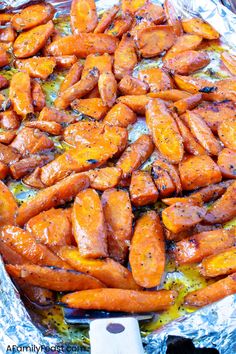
[0,0,236,354]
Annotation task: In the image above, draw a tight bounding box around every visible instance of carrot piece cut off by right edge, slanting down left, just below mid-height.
[204,181,236,224]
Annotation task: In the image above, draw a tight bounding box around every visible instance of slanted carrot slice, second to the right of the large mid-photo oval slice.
[182,111,222,155]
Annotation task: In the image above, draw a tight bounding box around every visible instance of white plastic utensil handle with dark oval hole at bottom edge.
[89,317,144,354]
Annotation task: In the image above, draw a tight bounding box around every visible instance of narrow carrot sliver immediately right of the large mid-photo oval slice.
[175,116,207,155]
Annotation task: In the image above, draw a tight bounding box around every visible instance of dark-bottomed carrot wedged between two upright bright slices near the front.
[101,188,133,263]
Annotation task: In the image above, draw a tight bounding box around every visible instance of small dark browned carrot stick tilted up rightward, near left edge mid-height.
[10,155,51,179]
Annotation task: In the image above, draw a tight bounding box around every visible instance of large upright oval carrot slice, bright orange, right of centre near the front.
[129,211,165,288]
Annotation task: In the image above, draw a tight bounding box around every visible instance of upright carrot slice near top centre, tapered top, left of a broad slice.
[114,33,138,80]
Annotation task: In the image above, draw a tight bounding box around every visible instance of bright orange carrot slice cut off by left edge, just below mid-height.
[0,181,18,226]
